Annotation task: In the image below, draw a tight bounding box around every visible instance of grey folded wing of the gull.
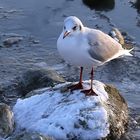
[87,30,122,62]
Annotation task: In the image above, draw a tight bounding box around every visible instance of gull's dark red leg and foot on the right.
[81,68,98,96]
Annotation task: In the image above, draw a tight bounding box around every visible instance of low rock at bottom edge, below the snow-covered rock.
[6,132,54,140]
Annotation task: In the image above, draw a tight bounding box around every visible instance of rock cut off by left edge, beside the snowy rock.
[0,103,14,137]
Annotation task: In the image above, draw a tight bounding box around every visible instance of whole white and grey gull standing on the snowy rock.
[57,16,132,96]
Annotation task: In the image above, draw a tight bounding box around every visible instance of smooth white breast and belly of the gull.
[57,34,101,67]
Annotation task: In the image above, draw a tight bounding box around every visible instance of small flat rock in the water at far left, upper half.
[3,37,23,47]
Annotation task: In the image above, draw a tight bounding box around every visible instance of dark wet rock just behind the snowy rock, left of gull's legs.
[18,68,65,96]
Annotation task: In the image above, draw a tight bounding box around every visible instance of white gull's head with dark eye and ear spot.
[63,16,84,39]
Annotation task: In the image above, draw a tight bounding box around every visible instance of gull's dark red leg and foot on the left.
[68,67,83,91]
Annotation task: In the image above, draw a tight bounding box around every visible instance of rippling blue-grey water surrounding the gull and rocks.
[0,0,140,139]
